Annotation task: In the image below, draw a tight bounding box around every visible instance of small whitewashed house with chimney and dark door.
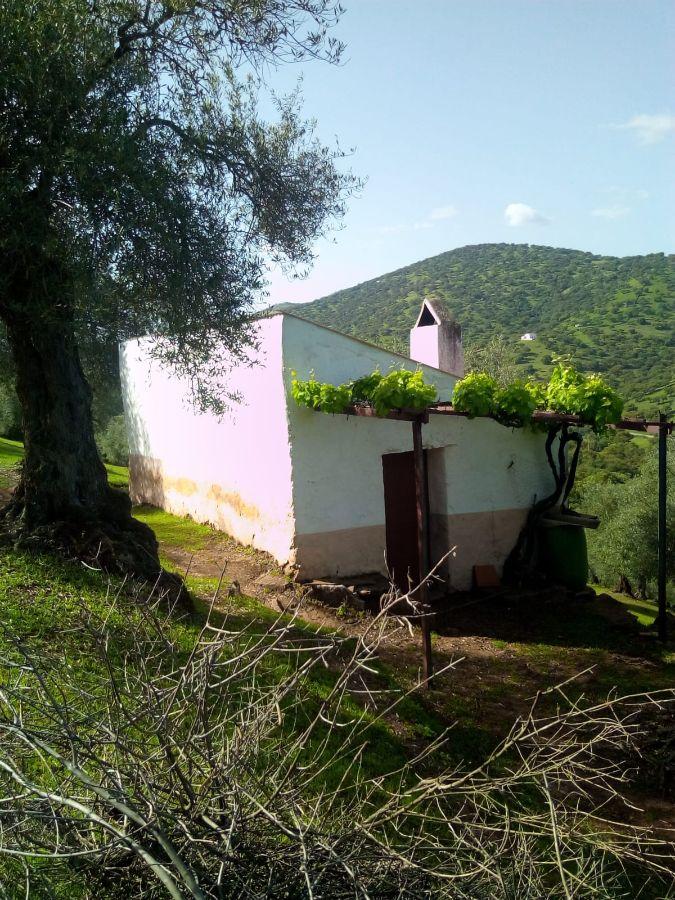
[120,300,552,589]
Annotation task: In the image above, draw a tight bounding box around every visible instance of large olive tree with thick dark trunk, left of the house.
[0,0,355,574]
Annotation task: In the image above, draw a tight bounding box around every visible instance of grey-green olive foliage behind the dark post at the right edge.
[581,438,675,597]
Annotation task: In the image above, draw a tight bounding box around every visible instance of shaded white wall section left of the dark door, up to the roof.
[283,317,457,575]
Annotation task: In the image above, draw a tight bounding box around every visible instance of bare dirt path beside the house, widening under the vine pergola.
[157,536,675,772]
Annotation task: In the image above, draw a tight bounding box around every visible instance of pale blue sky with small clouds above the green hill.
[262,0,675,302]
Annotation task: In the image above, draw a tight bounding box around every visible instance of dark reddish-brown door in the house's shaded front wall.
[382,452,419,592]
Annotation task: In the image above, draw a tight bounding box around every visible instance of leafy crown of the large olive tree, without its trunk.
[0,0,353,402]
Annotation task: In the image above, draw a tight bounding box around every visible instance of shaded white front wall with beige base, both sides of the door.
[283,317,553,587]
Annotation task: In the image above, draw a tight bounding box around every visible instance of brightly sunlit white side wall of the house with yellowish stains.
[120,316,295,560]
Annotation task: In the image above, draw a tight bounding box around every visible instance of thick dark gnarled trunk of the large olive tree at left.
[2,303,161,578]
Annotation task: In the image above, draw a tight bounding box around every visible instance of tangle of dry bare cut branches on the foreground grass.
[0,572,675,898]
